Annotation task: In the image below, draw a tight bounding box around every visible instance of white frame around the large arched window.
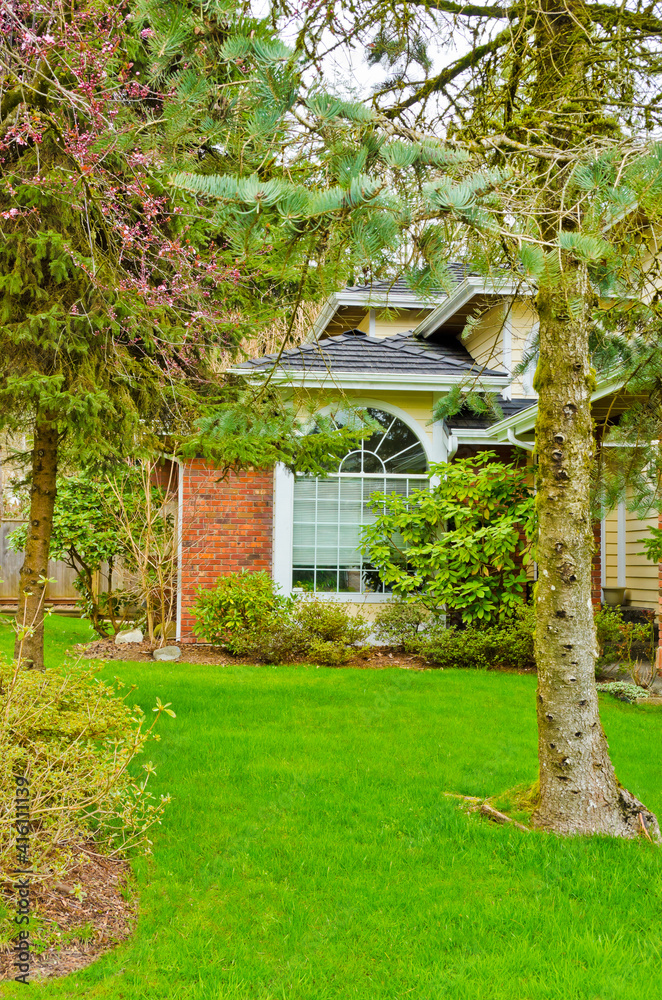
[272,397,448,604]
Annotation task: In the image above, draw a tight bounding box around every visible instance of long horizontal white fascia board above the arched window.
[229,368,509,392]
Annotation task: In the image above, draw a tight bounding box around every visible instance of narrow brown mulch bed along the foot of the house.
[79,639,428,670]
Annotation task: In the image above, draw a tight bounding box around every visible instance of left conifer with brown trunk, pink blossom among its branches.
[0,0,236,666]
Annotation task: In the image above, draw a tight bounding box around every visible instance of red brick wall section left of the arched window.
[181,459,273,642]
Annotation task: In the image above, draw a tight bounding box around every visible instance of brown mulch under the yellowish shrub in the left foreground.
[0,843,136,980]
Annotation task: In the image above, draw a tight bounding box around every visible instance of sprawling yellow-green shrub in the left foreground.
[0,661,174,879]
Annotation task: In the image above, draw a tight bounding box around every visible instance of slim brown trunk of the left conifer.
[14,414,58,670]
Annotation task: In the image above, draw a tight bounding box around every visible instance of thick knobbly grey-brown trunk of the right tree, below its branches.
[533,271,659,839]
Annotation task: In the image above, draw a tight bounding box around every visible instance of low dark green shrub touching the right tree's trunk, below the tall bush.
[418,608,535,670]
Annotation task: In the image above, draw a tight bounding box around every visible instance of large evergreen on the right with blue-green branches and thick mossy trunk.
[148,0,662,836]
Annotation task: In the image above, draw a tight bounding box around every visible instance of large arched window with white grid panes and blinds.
[292,407,429,594]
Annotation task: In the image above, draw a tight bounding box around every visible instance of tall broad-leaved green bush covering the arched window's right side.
[363,452,534,625]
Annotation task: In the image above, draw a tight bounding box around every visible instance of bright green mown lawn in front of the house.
[5,622,662,1000]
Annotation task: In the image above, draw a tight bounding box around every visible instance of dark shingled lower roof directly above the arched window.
[241,330,506,378]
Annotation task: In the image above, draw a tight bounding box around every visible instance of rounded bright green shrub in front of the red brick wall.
[193,571,293,655]
